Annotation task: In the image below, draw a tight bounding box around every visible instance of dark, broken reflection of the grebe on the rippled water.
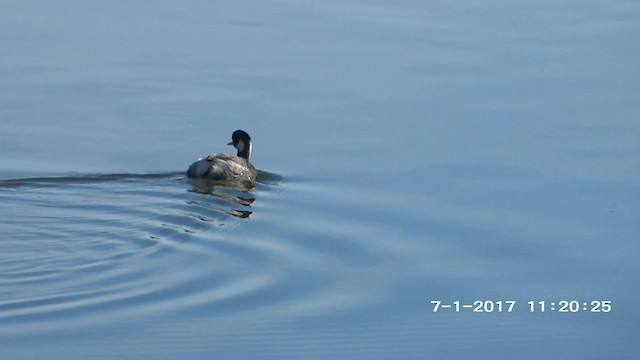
[189,179,256,218]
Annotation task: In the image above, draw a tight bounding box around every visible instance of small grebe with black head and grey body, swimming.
[187,130,258,181]
